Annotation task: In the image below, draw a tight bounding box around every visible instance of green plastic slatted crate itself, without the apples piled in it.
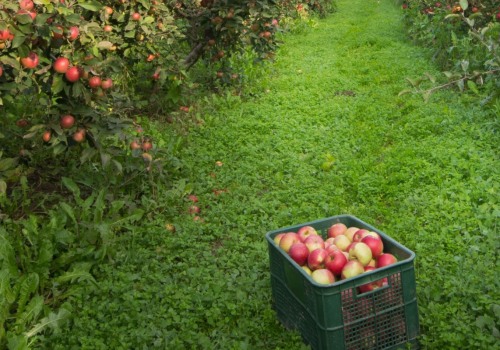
[266,215,419,350]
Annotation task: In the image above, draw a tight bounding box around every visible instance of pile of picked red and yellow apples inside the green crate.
[274,223,397,293]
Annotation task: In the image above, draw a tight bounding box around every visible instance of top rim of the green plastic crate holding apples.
[266,214,415,288]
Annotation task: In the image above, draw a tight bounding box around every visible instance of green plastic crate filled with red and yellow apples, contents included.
[266,215,419,350]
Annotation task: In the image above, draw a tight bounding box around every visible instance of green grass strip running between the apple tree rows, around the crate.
[41,0,500,349]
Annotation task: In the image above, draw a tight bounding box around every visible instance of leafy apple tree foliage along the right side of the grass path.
[402,0,500,102]
